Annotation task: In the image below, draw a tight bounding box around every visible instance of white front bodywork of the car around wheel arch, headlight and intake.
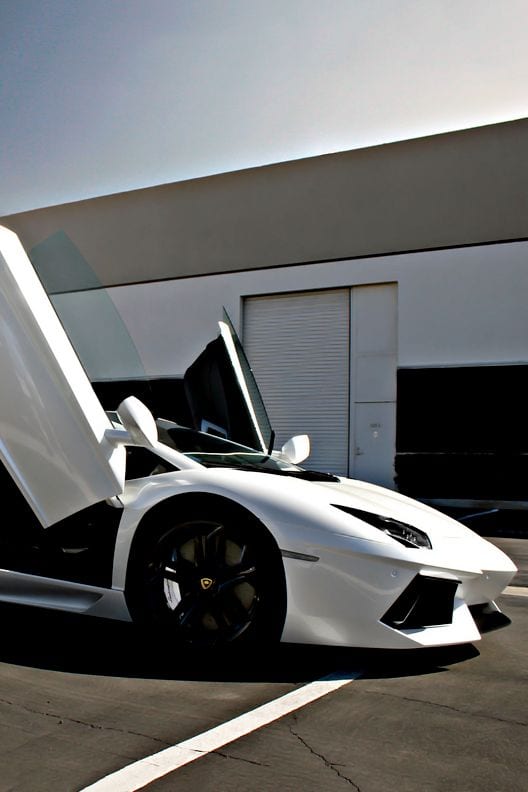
[106,468,516,649]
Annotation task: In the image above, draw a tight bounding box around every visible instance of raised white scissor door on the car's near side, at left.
[0,227,125,526]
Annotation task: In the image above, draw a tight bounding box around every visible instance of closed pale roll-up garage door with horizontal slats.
[243,289,350,475]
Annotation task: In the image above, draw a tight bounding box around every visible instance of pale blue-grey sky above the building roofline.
[0,0,528,216]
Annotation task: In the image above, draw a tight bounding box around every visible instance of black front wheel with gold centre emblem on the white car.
[130,508,285,649]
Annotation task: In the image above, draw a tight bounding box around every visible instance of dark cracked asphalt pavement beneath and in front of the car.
[0,524,528,792]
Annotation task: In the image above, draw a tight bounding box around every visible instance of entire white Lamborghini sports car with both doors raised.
[0,228,516,649]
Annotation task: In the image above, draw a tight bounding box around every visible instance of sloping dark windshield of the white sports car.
[157,420,335,481]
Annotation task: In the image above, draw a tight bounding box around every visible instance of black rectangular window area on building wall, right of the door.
[396,365,528,500]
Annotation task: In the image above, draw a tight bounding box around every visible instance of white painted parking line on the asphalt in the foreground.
[81,671,361,792]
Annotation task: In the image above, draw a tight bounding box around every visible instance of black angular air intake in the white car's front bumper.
[381,575,458,630]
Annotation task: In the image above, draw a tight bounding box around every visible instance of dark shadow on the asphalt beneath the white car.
[0,605,479,683]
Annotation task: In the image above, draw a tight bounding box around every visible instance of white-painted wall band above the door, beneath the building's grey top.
[80,242,528,376]
